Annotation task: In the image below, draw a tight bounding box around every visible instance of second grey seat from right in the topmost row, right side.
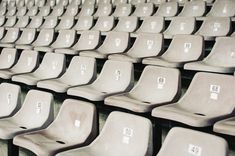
[178,0,206,17]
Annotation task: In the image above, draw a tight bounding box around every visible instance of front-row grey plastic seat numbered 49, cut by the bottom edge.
[157,127,229,156]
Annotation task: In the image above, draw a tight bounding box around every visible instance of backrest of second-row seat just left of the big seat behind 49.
[130,66,181,104]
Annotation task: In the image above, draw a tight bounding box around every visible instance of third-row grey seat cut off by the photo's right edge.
[184,37,235,73]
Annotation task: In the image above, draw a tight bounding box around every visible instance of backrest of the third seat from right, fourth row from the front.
[136,16,165,33]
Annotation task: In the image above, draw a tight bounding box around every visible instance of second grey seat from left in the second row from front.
[0,50,39,79]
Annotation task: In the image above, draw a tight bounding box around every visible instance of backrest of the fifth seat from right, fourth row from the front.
[92,16,114,32]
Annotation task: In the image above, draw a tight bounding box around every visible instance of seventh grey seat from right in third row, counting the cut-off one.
[32,29,55,51]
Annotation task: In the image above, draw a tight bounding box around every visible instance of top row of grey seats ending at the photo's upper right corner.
[0,0,235,19]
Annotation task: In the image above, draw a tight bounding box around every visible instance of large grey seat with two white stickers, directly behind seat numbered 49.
[152,73,235,127]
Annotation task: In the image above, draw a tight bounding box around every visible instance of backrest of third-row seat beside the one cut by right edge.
[161,35,204,62]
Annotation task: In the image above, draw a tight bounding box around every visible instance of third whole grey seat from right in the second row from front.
[67,60,134,101]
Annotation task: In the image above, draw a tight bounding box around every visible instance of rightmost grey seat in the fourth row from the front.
[196,17,231,40]
